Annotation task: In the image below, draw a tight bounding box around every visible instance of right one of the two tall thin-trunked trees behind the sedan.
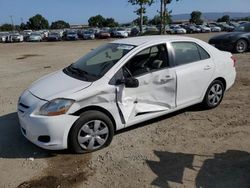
[160,0,179,34]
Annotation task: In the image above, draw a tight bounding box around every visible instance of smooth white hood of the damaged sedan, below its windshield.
[28,70,92,100]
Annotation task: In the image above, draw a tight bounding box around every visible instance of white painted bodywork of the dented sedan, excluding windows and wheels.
[17,36,236,150]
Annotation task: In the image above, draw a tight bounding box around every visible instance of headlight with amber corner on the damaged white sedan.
[39,98,75,116]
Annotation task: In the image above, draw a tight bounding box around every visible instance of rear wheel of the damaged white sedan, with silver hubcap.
[202,80,225,109]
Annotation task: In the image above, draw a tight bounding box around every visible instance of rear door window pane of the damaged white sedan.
[172,42,200,65]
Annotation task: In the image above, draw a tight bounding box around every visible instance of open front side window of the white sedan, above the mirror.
[123,44,168,77]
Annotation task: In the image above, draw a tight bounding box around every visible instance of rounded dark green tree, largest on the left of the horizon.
[27,14,49,30]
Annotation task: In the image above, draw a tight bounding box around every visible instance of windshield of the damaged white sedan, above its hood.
[64,43,135,81]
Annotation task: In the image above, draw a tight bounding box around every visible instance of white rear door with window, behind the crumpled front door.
[171,42,214,106]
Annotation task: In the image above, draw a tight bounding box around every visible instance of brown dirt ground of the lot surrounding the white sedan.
[0,34,250,188]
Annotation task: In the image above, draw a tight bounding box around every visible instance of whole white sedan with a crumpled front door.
[18,36,236,153]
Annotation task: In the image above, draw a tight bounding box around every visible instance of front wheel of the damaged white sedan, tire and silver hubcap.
[69,111,114,153]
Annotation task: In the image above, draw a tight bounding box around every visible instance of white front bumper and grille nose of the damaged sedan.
[18,92,79,150]
